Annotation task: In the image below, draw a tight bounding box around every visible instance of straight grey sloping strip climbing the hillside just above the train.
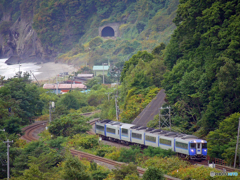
[132,89,166,126]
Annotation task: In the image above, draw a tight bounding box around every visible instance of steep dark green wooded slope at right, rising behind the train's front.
[163,0,240,162]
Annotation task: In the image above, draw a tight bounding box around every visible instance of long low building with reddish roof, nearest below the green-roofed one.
[43,84,87,94]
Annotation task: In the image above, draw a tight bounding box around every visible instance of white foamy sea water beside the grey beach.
[0,59,41,79]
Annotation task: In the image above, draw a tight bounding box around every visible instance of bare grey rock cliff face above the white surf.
[0,14,50,64]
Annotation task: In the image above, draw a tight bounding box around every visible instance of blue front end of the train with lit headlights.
[189,139,207,160]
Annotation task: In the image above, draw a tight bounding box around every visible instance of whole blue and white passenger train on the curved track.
[95,119,207,160]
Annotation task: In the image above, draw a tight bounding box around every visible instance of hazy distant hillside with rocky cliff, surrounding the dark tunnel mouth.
[0,0,178,65]
